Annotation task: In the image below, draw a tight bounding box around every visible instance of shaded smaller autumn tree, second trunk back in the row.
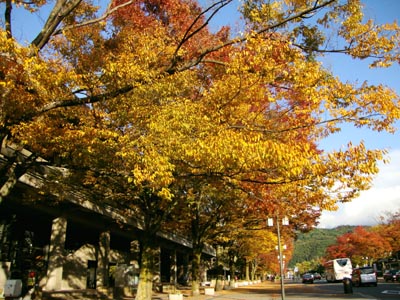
[165,178,245,295]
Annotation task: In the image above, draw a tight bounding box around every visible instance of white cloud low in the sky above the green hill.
[318,150,400,228]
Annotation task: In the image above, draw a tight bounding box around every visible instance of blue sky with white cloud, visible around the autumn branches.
[0,0,400,228]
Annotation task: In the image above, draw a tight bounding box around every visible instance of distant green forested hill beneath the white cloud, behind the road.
[289,225,356,267]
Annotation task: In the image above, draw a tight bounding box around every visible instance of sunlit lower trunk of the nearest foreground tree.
[135,242,156,300]
